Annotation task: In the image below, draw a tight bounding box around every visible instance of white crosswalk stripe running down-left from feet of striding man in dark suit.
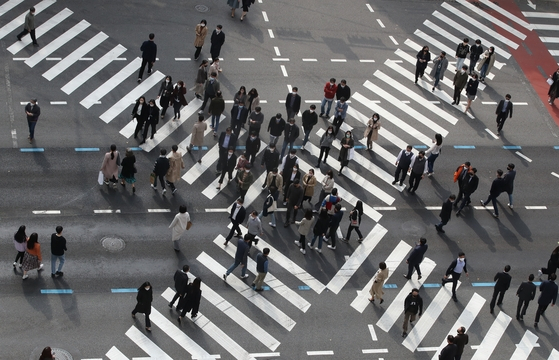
[402,281,460,352]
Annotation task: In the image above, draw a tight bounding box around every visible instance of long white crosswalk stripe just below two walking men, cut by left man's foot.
[196,250,296,331]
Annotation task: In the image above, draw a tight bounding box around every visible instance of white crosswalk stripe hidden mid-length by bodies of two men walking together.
[214,235,311,312]
